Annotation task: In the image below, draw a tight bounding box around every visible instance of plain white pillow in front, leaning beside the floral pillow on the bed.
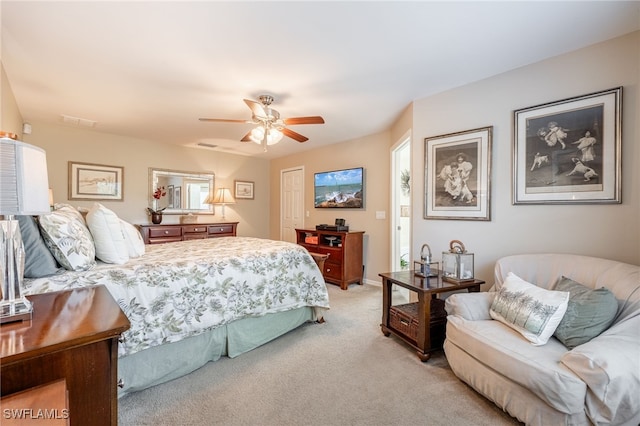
[87,203,129,265]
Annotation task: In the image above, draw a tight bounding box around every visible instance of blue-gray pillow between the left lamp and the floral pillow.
[16,216,60,278]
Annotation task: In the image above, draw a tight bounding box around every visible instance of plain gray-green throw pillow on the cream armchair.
[553,277,618,349]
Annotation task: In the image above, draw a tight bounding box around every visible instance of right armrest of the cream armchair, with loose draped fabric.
[560,315,640,425]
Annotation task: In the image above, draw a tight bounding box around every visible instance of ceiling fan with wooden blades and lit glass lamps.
[199,95,324,151]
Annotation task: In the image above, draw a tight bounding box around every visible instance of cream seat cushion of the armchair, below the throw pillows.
[447,314,587,414]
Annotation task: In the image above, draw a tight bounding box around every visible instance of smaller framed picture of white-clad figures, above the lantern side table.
[424,126,493,220]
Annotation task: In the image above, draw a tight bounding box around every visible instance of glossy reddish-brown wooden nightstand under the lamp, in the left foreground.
[0,286,130,426]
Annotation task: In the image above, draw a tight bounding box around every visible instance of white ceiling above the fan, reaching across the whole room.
[0,0,640,158]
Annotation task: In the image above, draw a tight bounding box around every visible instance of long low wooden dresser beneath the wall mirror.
[137,222,238,244]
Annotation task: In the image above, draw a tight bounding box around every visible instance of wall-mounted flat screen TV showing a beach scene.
[313,167,364,209]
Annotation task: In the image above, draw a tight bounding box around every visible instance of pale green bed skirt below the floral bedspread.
[118,307,317,398]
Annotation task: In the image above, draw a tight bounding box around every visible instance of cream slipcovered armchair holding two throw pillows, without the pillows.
[444,254,640,426]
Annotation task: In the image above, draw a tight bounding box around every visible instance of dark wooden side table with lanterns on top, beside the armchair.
[379,271,484,361]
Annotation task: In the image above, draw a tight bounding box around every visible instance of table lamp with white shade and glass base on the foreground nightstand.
[0,136,51,324]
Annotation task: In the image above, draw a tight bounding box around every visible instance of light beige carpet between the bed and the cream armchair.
[118,285,520,426]
